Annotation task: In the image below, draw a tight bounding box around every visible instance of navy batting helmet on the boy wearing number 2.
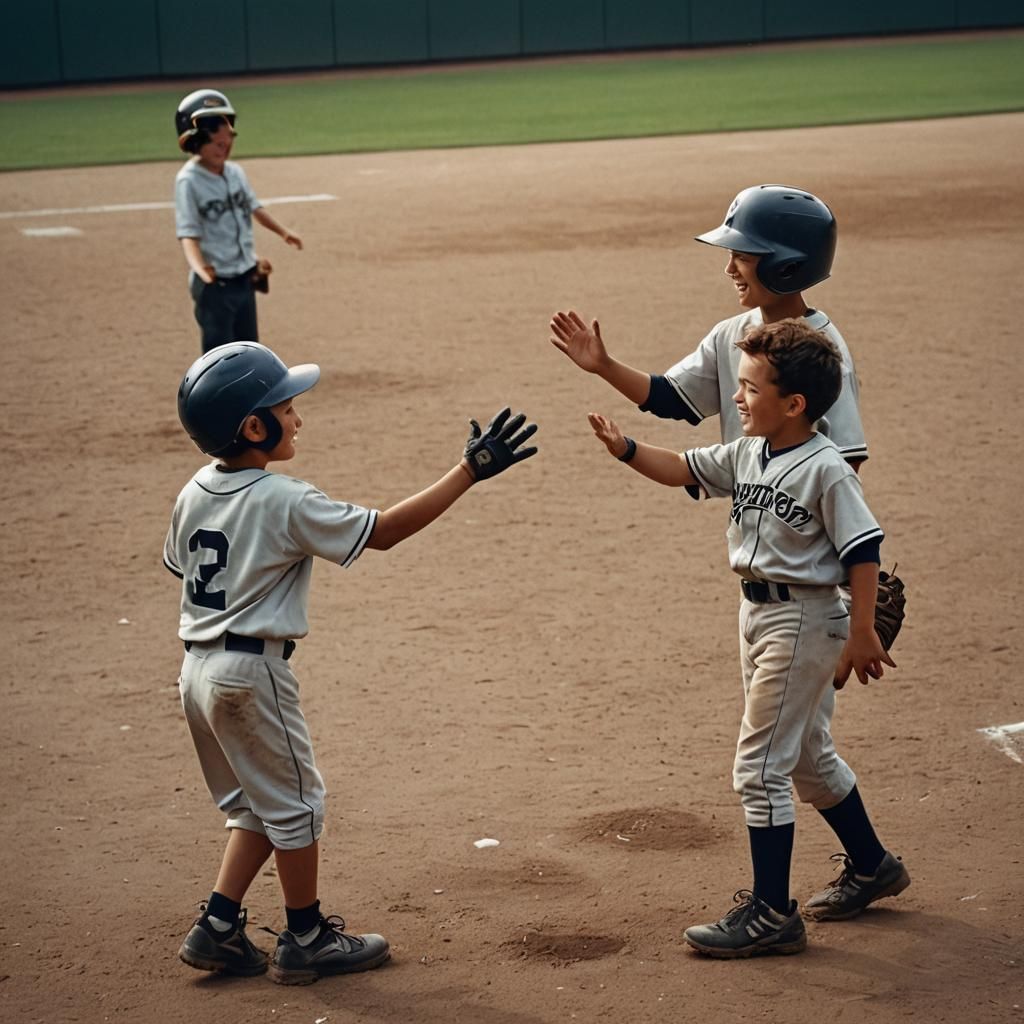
[178,341,319,455]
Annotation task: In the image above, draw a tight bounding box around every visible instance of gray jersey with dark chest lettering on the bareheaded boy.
[685,434,884,587]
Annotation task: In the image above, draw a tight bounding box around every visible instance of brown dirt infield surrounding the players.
[0,115,1024,1024]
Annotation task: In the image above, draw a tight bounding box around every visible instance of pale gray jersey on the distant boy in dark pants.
[174,159,262,278]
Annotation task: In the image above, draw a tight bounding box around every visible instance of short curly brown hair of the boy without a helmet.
[736,319,843,423]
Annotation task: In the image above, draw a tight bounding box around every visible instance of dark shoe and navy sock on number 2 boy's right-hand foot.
[269,901,391,985]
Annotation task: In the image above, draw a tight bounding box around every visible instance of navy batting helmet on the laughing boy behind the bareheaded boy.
[696,185,836,295]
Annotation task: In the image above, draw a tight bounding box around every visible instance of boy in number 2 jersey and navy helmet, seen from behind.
[164,342,537,984]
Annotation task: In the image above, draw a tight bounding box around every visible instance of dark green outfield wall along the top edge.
[0,0,1024,88]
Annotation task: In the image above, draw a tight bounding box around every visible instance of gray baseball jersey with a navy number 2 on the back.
[164,463,378,643]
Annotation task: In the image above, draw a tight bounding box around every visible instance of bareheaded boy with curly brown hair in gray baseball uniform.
[590,319,910,958]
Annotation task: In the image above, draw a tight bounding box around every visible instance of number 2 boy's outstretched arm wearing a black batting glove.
[367,409,537,551]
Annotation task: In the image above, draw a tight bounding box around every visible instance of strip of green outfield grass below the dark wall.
[0,32,1024,170]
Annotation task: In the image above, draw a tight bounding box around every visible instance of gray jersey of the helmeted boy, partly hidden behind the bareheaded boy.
[665,309,867,460]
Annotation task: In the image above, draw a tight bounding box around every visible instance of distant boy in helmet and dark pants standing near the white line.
[174,89,302,352]
